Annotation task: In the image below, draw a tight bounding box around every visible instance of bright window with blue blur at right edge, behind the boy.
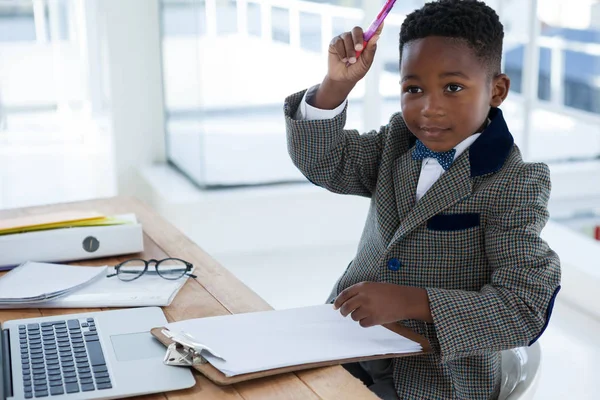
[523,0,600,163]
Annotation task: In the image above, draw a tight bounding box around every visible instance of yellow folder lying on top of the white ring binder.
[0,211,127,235]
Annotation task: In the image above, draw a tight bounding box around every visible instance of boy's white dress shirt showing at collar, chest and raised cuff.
[295,86,482,201]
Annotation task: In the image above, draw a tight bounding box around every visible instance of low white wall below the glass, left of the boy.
[139,166,369,254]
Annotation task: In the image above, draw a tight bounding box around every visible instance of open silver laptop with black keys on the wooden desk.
[0,307,196,400]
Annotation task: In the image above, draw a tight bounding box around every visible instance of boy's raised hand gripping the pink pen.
[327,24,383,85]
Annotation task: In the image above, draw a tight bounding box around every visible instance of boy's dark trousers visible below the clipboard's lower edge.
[343,358,399,400]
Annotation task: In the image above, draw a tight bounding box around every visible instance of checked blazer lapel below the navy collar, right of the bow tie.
[390,152,473,246]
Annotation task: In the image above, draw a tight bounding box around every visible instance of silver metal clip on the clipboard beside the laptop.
[162,329,225,366]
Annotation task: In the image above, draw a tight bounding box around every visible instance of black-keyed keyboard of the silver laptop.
[19,318,112,399]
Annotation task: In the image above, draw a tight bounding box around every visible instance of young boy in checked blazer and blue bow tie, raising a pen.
[285,0,560,399]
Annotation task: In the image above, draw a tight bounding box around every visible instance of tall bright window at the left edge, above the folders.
[0,0,113,208]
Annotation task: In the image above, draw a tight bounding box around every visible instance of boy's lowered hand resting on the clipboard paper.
[333,282,433,328]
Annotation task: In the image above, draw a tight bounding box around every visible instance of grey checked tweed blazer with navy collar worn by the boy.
[284,91,561,399]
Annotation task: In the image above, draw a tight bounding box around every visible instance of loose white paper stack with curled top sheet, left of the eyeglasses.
[0,262,106,307]
